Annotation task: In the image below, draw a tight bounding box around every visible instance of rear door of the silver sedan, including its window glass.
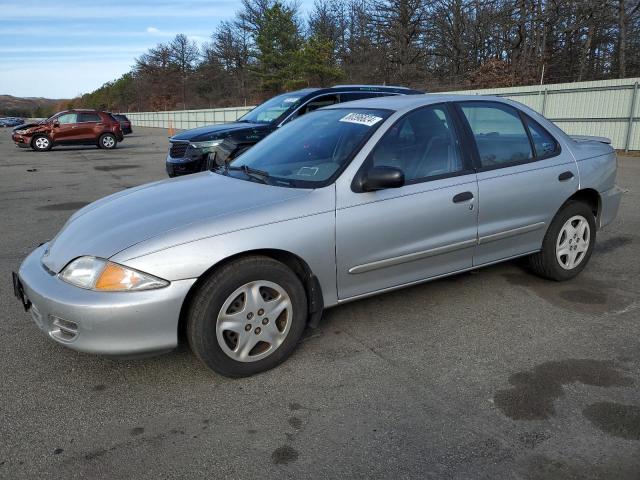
[457,101,578,265]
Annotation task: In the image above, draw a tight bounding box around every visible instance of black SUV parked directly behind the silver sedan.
[166,85,423,177]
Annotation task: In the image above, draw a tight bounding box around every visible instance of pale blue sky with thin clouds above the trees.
[0,0,313,98]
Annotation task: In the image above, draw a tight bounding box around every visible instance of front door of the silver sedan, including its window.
[336,104,478,300]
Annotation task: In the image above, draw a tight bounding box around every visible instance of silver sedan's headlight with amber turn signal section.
[58,257,169,292]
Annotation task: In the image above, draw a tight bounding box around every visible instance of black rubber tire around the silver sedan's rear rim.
[529,200,596,282]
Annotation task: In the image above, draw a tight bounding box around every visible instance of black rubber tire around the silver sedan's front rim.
[187,256,308,377]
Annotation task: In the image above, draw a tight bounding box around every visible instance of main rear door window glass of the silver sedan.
[460,102,534,168]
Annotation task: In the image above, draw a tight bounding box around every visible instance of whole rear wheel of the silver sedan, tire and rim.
[530,201,596,281]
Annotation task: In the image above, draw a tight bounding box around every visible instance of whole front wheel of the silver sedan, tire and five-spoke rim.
[187,256,307,377]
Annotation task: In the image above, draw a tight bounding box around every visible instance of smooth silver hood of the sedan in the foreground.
[42,172,310,272]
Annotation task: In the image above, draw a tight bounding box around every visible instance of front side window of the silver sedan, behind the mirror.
[368,105,464,183]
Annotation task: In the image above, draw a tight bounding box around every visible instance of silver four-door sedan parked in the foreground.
[14,95,621,376]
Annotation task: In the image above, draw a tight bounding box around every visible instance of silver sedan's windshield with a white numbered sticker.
[226,108,391,188]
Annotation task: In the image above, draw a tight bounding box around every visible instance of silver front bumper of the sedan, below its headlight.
[18,244,195,356]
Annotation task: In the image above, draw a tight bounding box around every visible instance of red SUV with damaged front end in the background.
[12,110,124,152]
